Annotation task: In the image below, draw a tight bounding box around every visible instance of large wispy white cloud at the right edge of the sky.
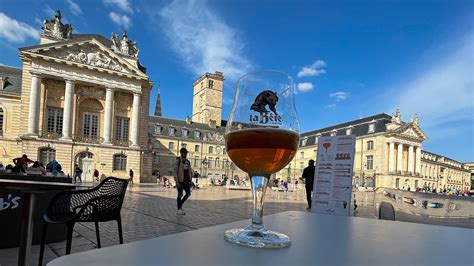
[389,34,474,130]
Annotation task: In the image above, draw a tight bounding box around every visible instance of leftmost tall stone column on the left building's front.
[28,72,41,137]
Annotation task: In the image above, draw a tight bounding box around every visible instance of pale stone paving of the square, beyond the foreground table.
[0,184,471,266]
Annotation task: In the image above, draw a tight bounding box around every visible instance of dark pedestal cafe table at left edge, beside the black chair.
[0,179,89,266]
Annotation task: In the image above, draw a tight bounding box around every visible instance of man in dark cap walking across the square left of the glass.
[174,148,194,215]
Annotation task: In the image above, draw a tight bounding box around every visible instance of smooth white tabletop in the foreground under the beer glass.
[48,211,474,266]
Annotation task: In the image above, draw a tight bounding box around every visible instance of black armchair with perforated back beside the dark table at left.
[38,177,128,265]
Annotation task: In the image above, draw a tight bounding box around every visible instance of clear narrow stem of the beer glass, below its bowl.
[250,175,270,229]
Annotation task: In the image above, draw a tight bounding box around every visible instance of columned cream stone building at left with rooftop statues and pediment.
[0,11,152,181]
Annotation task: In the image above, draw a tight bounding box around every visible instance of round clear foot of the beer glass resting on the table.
[224,225,291,248]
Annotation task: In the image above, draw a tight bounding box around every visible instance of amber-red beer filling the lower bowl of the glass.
[225,128,299,175]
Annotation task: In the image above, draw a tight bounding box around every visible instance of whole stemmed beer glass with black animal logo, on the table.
[224,70,300,248]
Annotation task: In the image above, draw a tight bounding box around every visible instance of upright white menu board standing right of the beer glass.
[311,135,355,215]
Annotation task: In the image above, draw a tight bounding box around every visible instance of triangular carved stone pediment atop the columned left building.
[21,39,146,77]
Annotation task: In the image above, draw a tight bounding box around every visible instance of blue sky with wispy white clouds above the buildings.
[0,0,474,161]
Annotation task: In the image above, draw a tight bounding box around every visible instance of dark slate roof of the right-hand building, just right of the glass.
[301,113,392,146]
